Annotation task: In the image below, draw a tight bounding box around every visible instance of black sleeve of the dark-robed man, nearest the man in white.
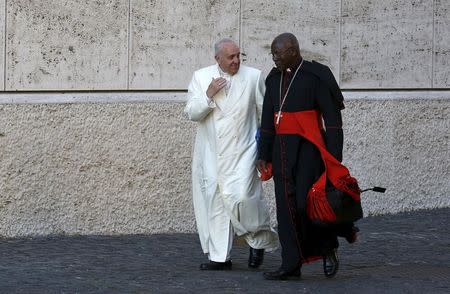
[258,80,275,162]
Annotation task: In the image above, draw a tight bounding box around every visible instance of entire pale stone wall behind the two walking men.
[0,0,450,237]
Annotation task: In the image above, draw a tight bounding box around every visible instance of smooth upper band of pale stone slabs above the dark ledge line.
[0,0,450,91]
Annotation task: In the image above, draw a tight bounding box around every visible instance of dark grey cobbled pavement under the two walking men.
[0,208,450,293]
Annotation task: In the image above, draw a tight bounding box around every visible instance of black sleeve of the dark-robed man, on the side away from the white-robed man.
[316,82,344,161]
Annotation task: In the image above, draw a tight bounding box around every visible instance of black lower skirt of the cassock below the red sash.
[272,135,339,271]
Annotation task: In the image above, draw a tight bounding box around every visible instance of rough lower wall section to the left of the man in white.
[0,103,194,237]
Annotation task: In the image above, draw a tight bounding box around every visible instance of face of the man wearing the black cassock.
[270,39,301,71]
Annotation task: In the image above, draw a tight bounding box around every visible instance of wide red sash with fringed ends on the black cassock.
[274,110,361,223]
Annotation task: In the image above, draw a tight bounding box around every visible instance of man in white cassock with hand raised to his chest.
[184,39,278,270]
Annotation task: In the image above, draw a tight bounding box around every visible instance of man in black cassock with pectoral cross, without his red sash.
[257,33,357,280]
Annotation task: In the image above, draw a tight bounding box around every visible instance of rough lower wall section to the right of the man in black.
[343,100,450,214]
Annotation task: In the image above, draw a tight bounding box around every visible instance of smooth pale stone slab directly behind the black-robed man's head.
[241,0,340,78]
